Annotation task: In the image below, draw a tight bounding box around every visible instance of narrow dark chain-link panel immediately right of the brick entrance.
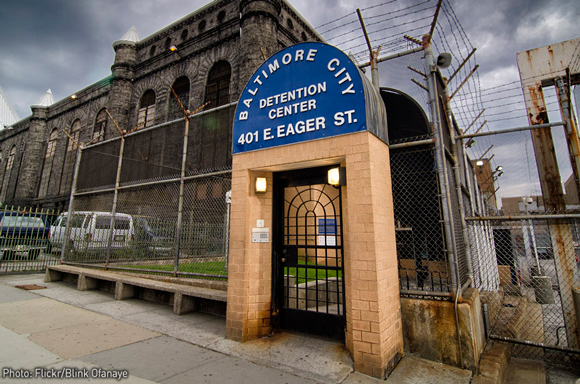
[390,144,450,292]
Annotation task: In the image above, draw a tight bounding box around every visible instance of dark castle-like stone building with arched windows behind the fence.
[0,0,321,210]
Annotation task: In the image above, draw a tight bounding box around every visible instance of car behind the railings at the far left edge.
[0,211,49,260]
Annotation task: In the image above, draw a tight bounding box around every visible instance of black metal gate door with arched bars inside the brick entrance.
[273,169,345,337]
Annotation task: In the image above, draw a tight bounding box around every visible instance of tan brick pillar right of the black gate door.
[343,134,403,378]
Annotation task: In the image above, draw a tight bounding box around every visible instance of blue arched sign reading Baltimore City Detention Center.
[233,43,367,154]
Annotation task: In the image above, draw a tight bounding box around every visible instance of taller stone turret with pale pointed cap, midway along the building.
[107,27,139,129]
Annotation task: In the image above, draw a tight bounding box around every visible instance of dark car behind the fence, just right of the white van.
[133,216,175,256]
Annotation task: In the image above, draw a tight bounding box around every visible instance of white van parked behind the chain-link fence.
[49,211,135,251]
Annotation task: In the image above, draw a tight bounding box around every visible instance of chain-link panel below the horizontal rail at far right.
[468,215,580,358]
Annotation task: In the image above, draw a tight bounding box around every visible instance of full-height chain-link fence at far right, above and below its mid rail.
[465,126,580,366]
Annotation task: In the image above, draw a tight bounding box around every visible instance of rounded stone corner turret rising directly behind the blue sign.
[240,0,282,84]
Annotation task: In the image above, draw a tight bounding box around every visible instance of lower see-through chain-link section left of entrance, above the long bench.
[59,170,231,278]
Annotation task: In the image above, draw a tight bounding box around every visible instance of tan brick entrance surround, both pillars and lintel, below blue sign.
[226,132,403,378]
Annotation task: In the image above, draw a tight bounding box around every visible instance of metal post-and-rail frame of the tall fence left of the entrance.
[60,103,236,279]
